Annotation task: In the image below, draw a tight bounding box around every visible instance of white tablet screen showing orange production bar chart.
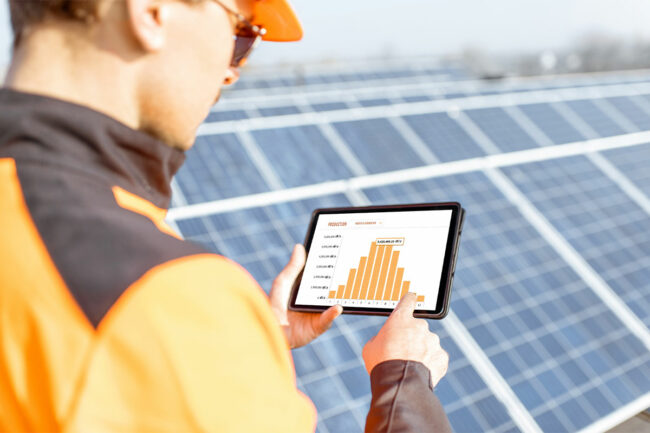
[297,211,451,309]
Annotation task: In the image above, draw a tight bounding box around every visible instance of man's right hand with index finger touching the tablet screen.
[363,293,449,387]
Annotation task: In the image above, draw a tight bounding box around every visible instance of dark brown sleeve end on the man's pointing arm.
[366,360,451,433]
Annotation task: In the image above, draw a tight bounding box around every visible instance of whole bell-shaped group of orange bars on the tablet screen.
[328,241,424,302]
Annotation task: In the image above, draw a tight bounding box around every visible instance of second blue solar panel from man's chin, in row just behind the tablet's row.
[252,125,352,187]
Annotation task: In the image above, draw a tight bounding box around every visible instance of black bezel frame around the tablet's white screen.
[288,202,465,319]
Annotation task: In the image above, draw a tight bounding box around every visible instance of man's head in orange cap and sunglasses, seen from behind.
[7,0,301,148]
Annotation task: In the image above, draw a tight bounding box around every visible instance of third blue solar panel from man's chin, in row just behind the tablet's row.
[333,119,423,173]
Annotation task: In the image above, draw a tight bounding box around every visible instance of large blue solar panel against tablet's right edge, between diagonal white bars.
[365,173,650,432]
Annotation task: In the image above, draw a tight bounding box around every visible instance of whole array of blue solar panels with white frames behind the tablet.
[170,66,650,433]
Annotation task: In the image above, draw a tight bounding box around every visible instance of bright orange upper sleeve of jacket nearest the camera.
[66,254,316,433]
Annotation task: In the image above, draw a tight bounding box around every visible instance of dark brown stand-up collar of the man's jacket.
[0,88,185,208]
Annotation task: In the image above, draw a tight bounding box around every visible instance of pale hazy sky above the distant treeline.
[0,0,650,68]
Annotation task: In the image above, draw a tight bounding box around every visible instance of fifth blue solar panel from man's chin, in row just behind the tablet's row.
[465,108,539,152]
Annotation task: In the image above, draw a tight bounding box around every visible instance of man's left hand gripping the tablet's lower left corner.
[269,245,343,349]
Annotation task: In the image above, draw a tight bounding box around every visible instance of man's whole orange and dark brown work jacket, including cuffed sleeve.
[0,89,449,433]
